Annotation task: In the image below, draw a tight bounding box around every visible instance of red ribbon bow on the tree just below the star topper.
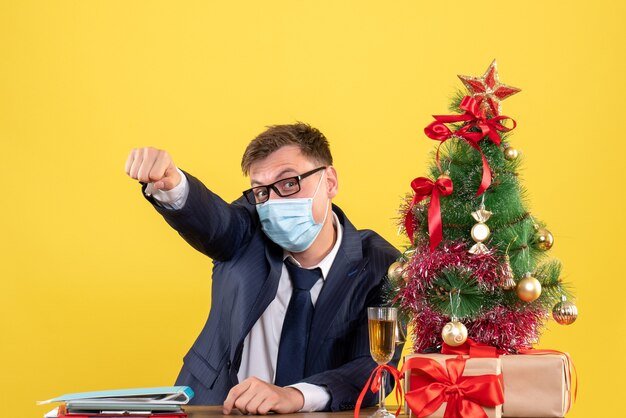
[424,96,517,196]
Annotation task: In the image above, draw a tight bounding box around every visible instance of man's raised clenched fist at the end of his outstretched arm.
[124,147,181,190]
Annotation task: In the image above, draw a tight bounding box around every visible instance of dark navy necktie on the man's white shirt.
[274,260,322,386]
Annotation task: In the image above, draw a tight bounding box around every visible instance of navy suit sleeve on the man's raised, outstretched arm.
[143,173,255,261]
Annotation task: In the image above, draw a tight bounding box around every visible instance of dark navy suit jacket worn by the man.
[148,174,401,411]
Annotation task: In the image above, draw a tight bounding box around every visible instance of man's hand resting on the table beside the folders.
[223,377,304,415]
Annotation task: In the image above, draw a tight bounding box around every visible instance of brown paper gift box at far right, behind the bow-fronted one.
[500,353,571,418]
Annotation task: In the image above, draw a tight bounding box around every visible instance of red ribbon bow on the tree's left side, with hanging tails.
[404,176,452,251]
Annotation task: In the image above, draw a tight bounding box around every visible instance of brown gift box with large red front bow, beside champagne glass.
[403,354,504,418]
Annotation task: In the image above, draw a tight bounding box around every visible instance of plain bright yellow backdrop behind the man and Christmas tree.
[0,0,626,417]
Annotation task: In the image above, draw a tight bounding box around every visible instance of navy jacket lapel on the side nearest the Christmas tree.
[306,205,364,369]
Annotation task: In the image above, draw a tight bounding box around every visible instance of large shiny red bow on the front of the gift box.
[402,356,504,418]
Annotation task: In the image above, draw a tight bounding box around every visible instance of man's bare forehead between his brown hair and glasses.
[250,145,315,185]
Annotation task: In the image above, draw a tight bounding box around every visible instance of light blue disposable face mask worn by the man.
[256,172,330,253]
